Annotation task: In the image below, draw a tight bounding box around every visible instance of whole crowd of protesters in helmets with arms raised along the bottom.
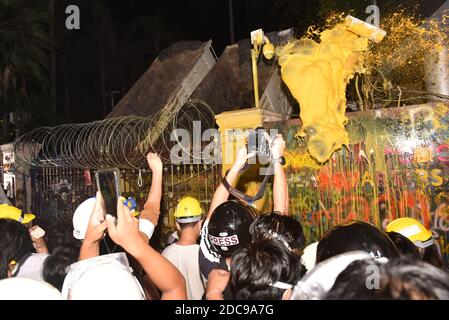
[0,135,449,300]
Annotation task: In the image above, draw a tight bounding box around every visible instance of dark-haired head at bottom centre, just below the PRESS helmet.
[231,240,301,300]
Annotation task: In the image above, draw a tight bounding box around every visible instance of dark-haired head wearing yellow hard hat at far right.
[386,218,444,268]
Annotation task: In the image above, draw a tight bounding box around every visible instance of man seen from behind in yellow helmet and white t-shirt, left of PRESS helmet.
[162,197,204,300]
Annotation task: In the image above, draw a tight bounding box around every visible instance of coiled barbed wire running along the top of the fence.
[13,100,215,169]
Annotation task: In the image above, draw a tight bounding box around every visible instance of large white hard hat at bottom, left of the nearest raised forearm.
[62,252,145,300]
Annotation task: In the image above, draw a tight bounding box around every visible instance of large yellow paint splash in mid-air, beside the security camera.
[277,16,380,163]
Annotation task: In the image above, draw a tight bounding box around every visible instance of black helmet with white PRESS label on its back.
[208,200,257,257]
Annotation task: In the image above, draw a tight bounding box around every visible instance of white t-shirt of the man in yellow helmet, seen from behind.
[162,243,204,300]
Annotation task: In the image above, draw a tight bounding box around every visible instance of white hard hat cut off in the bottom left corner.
[0,278,63,300]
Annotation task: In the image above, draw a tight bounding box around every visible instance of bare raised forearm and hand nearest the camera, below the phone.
[106,200,187,300]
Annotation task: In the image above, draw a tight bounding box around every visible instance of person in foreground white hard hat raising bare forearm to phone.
[62,198,187,300]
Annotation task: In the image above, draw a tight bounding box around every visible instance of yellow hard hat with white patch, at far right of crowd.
[386,218,433,248]
